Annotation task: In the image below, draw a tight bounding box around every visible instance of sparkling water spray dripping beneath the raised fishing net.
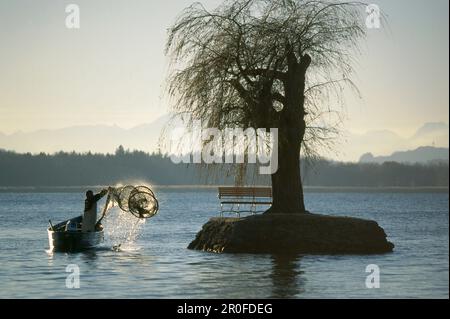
[103,207,146,251]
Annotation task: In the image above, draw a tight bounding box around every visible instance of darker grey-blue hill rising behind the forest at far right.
[360,146,449,164]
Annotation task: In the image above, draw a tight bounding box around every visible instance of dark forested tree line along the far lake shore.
[0,147,449,187]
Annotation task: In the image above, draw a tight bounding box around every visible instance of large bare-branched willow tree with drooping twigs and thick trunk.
[166,0,365,213]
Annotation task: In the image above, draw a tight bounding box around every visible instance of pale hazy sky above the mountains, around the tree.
[0,0,449,135]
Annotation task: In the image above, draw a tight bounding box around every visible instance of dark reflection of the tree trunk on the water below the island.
[270,255,304,299]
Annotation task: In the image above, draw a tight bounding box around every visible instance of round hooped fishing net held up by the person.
[110,185,159,219]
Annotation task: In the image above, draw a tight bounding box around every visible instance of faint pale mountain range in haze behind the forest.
[0,115,449,162]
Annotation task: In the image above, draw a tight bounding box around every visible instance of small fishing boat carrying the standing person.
[47,216,104,252]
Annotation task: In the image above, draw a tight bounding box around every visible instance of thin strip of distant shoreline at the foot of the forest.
[0,185,449,193]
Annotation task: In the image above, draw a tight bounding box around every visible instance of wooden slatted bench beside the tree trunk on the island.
[219,187,272,217]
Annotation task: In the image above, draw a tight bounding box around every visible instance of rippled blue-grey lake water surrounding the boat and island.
[0,189,449,298]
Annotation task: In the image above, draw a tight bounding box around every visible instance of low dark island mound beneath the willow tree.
[188,213,394,254]
